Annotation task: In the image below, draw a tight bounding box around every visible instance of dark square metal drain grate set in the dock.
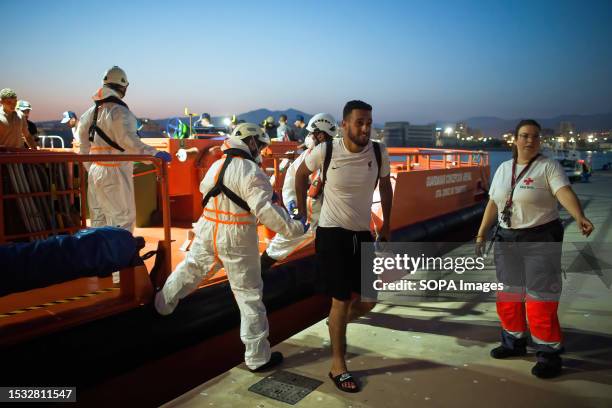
[249,370,323,405]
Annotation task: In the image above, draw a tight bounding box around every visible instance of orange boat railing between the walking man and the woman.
[388,147,489,171]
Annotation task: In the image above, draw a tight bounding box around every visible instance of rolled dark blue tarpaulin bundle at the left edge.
[0,227,140,296]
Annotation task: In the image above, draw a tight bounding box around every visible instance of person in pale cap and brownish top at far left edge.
[0,88,38,149]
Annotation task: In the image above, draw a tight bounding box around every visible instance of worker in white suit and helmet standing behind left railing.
[77,66,172,232]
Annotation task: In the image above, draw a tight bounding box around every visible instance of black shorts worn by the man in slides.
[315,227,376,300]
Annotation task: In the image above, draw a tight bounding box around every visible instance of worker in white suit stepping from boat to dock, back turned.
[154,123,307,371]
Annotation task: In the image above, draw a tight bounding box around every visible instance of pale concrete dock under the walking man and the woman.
[164,172,612,408]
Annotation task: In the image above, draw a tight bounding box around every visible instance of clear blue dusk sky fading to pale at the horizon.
[0,0,612,123]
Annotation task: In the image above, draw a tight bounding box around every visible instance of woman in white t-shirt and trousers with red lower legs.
[476,120,593,378]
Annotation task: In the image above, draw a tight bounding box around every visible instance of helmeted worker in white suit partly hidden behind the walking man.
[261,113,338,272]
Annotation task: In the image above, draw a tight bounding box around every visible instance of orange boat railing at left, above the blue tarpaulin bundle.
[0,149,172,280]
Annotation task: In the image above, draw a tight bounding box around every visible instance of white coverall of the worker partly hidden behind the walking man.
[266,149,323,261]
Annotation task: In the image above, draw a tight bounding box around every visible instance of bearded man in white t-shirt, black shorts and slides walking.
[295,101,393,392]
